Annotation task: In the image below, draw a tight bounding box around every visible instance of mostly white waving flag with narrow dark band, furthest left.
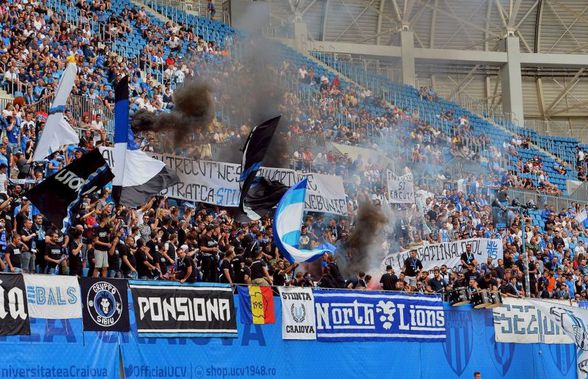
[33,58,80,162]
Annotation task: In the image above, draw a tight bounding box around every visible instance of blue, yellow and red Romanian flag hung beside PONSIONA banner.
[237,286,276,324]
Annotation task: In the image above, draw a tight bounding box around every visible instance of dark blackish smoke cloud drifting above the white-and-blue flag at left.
[131,80,214,146]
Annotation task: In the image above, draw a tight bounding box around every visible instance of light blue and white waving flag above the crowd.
[273,179,334,262]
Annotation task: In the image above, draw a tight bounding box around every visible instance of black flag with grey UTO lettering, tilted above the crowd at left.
[24,149,114,226]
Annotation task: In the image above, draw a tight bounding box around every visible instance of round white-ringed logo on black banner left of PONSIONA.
[86,282,123,327]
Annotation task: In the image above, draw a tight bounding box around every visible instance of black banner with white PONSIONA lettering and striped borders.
[129,280,237,337]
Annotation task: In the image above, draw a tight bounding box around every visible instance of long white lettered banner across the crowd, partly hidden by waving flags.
[101,148,347,215]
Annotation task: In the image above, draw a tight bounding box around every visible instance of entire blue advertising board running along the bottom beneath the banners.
[0,298,576,379]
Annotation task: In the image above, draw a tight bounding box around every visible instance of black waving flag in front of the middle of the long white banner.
[239,116,288,220]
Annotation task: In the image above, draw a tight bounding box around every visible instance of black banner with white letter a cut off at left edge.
[0,274,31,336]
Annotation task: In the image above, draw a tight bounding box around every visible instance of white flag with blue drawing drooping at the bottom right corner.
[529,299,588,378]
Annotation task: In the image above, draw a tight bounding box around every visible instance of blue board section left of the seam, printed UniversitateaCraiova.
[0,318,120,379]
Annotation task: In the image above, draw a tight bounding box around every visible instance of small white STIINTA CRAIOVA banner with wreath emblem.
[279,287,316,340]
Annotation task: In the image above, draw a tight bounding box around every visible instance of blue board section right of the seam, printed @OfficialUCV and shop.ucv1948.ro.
[113,298,576,379]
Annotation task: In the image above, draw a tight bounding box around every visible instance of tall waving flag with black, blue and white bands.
[112,76,179,208]
